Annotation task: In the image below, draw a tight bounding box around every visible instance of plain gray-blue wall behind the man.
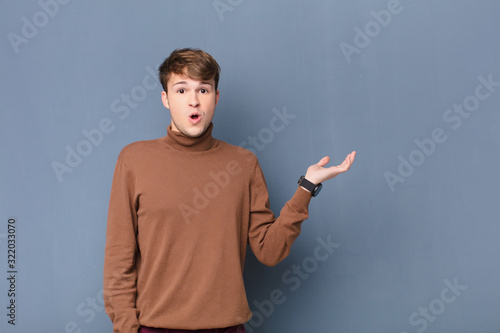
[0,0,500,333]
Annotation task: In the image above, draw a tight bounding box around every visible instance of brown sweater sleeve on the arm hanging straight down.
[103,159,139,333]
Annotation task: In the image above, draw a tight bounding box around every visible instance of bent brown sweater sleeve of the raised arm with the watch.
[248,159,311,266]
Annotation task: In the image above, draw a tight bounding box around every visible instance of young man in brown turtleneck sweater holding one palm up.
[104,49,355,333]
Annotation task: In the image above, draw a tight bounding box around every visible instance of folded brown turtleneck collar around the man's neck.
[164,122,216,151]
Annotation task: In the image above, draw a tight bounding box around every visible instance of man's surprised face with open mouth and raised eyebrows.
[161,74,219,138]
